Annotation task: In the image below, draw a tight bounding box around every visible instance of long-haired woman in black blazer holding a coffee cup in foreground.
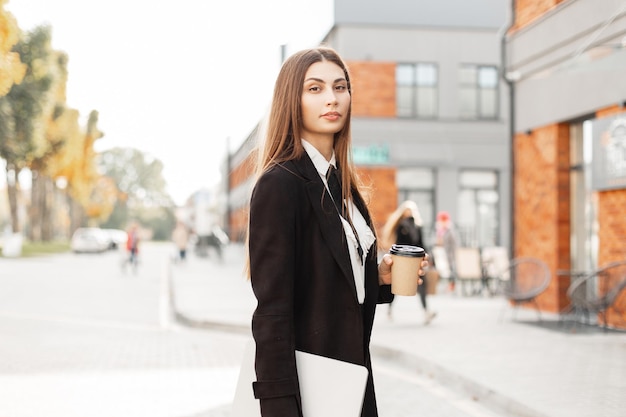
[248,47,425,417]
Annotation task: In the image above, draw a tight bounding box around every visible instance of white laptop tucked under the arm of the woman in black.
[231,341,368,417]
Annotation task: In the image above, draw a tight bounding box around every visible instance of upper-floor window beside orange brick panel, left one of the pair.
[396,63,438,119]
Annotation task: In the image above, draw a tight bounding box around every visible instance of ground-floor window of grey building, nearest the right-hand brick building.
[457,170,500,247]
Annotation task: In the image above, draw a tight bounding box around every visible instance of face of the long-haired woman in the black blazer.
[302,61,350,144]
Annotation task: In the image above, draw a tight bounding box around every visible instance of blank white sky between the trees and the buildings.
[6,0,332,204]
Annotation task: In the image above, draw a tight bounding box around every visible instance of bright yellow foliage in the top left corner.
[0,0,26,97]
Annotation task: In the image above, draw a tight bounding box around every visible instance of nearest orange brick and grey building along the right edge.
[503,0,626,328]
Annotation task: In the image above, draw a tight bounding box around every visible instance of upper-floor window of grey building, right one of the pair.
[459,65,498,120]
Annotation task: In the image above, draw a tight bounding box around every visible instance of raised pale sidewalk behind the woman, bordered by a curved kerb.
[171,245,626,417]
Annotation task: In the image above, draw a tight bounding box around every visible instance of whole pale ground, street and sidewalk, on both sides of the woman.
[0,246,626,417]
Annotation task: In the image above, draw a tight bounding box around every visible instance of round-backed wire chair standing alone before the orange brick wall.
[499,257,552,320]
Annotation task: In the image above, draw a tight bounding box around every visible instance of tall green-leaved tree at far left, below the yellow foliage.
[0,26,53,232]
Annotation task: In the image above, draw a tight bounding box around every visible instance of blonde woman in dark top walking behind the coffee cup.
[381,200,437,324]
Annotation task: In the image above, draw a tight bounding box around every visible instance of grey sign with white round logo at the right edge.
[592,115,626,190]
